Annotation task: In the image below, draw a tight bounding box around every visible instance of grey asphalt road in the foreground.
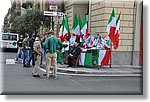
[2,52,142,94]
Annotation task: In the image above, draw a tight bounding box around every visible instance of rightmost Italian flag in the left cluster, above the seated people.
[81,13,88,38]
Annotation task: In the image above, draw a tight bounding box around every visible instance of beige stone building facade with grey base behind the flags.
[65,0,143,65]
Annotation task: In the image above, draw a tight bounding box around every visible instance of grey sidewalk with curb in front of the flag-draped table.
[55,64,143,76]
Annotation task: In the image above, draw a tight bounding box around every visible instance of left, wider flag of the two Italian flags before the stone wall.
[106,8,116,44]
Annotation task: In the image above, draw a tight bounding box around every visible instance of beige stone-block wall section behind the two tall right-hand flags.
[91,0,135,51]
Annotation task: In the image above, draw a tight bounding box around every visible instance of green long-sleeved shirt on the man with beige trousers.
[43,36,62,54]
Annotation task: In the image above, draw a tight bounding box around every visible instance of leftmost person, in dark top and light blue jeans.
[15,35,23,61]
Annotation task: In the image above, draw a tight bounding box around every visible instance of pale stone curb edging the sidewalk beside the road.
[40,68,143,77]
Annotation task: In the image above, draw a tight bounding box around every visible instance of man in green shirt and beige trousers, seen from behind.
[43,32,63,79]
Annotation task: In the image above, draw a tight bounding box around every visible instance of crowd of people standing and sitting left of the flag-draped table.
[16,31,81,79]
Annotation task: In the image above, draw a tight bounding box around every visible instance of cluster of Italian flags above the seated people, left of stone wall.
[59,13,88,42]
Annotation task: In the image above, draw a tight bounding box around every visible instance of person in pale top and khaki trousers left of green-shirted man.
[32,37,42,77]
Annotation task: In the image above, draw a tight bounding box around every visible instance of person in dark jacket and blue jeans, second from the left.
[23,33,31,67]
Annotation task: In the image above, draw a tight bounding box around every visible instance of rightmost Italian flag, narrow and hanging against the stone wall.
[114,12,121,49]
